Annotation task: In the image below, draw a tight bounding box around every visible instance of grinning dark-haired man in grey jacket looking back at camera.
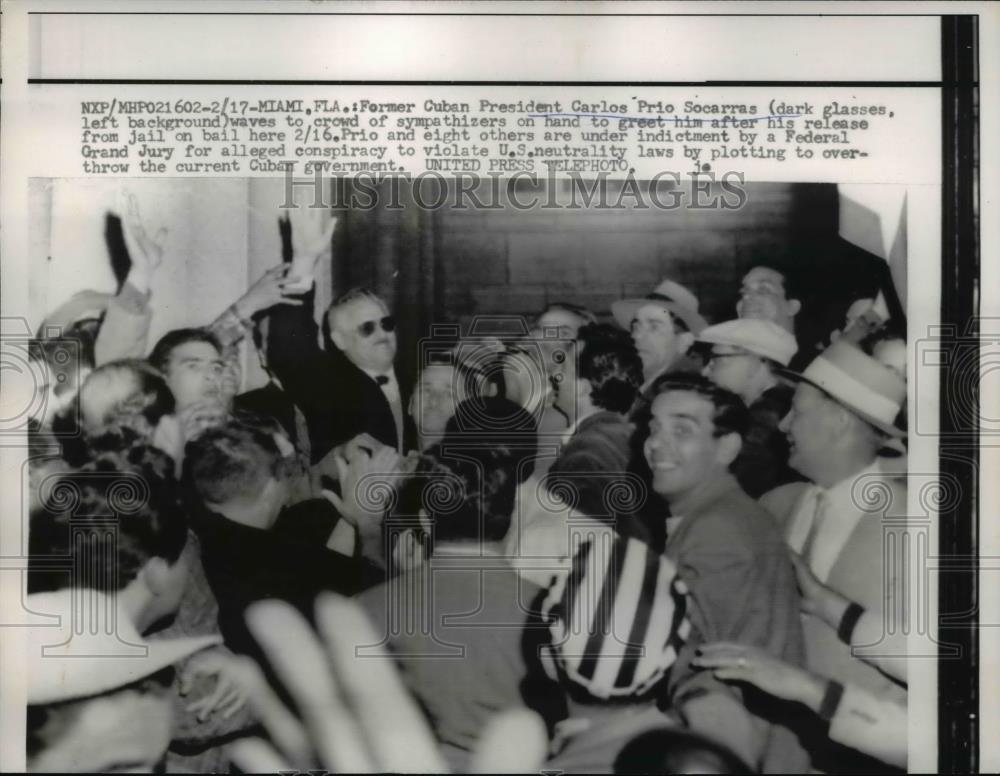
[643,375,807,773]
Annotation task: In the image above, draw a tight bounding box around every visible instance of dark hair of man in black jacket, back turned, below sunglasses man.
[184,417,290,504]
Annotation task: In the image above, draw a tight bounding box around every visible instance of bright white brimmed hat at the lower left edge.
[26,588,222,704]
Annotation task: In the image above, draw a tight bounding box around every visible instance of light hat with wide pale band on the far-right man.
[782,340,906,437]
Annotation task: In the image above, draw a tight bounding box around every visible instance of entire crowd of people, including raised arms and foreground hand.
[26,200,907,773]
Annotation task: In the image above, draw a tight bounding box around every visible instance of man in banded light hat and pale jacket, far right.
[760,340,909,773]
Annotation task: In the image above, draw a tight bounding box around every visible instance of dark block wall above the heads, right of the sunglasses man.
[426,183,887,358]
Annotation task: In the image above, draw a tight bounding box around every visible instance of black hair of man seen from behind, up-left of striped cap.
[399,398,537,542]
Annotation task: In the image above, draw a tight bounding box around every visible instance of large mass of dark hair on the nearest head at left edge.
[28,429,187,593]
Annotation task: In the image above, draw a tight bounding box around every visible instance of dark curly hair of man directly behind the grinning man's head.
[576,323,642,414]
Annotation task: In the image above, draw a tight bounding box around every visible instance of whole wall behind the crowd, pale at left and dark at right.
[30,179,888,387]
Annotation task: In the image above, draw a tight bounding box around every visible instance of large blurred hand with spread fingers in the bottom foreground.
[230,593,546,773]
